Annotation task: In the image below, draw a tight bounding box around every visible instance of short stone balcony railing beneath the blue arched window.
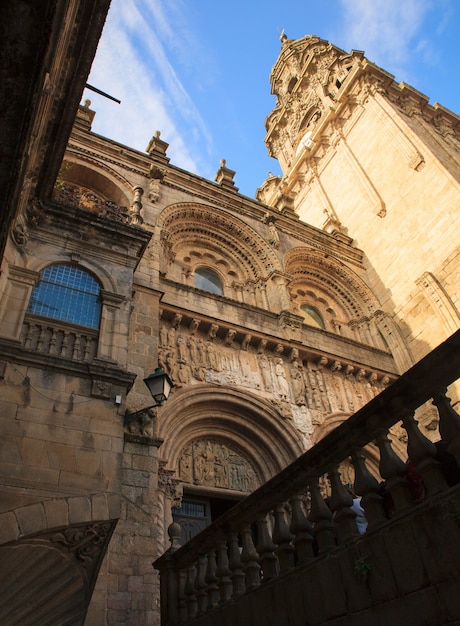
[21,315,99,363]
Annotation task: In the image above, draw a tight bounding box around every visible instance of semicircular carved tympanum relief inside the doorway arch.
[178,439,261,492]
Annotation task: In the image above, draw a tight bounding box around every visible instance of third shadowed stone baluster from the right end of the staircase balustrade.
[375,431,412,513]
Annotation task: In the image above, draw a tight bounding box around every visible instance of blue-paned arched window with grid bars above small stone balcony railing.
[27,265,101,328]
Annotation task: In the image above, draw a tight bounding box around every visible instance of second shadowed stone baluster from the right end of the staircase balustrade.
[403,414,447,494]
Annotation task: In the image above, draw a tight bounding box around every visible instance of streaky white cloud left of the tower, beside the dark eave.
[83,0,216,176]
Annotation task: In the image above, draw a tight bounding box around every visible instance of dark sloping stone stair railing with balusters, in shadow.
[154,331,460,626]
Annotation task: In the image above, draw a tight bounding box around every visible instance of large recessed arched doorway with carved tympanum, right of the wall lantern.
[158,384,303,540]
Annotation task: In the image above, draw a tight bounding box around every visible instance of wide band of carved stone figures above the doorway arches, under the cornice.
[158,315,396,448]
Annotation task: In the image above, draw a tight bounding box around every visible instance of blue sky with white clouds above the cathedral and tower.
[83,0,460,197]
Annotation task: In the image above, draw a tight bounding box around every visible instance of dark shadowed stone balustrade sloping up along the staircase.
[154,331,460,626]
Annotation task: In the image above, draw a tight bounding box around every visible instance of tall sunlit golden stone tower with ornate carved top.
[257,35,460,359]
